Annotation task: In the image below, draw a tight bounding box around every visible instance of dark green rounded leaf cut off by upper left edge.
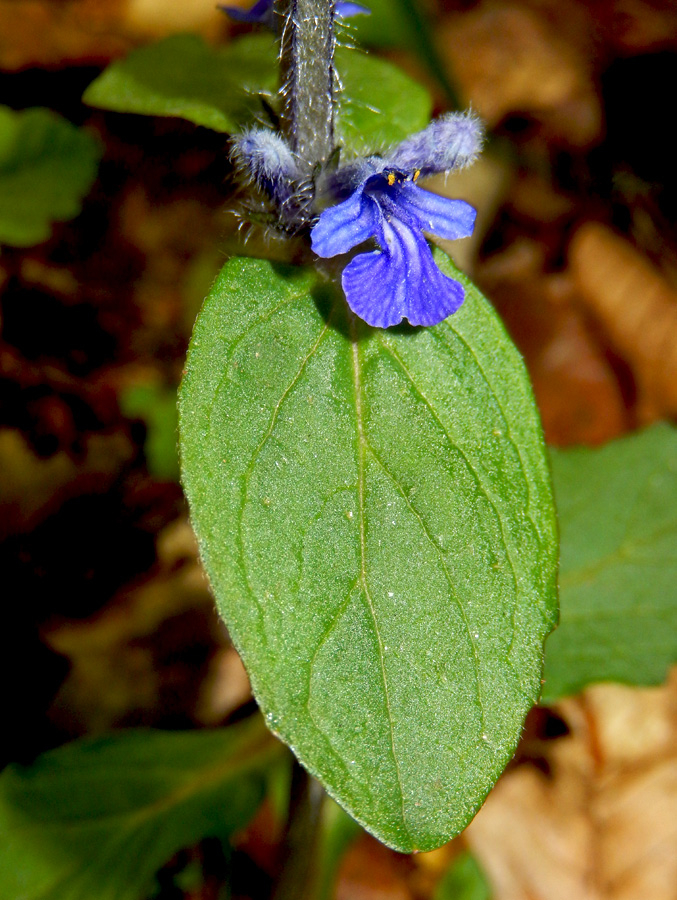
[0,106,101,247]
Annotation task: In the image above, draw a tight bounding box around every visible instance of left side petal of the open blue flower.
[310,187,381,257]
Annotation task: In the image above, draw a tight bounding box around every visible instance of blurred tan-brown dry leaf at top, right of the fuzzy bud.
[440,0,602,146]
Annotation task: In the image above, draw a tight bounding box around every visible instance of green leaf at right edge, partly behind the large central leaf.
[544,424,677,701]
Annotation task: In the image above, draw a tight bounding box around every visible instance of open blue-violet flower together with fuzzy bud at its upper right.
[311,113,484,328]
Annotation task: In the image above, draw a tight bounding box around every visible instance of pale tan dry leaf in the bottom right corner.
[466,676,677,900]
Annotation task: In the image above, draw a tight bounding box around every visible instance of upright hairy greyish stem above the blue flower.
[275,0,335,168]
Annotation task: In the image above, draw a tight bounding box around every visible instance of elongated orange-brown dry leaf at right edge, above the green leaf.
[569,222,677,421]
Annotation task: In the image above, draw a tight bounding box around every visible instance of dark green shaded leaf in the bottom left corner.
[0,717,281,900]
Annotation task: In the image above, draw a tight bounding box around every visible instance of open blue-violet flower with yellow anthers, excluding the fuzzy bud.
[311,167,475,328]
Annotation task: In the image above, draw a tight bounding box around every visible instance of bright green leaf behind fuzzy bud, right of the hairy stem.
[336,48,432,155]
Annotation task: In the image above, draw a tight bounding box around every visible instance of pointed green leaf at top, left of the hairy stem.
[82,34,278,132]
